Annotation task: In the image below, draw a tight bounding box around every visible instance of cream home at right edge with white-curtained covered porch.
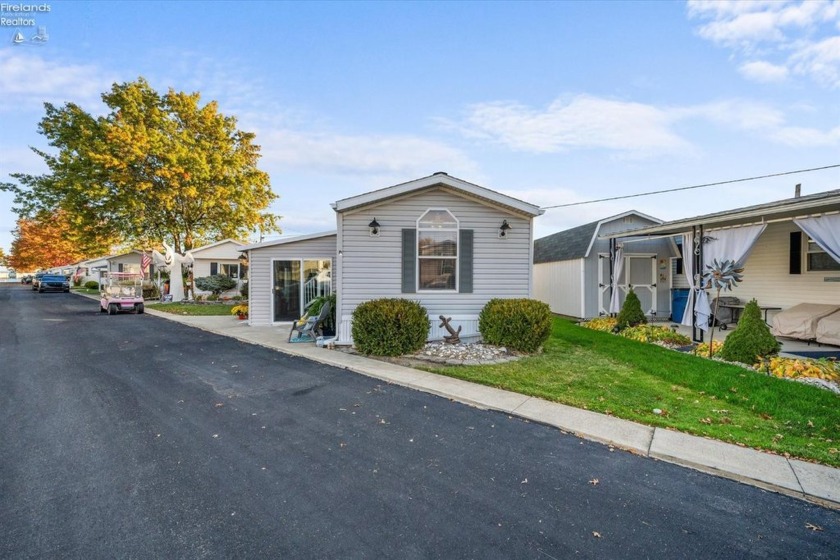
[606,190,840,336]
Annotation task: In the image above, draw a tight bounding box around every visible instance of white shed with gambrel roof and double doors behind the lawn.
[534,210,682,320]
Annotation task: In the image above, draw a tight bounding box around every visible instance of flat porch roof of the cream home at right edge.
[604,189,840,238]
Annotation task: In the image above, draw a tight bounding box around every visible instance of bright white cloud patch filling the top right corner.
[688,0,840,89]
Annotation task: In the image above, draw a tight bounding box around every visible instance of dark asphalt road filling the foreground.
[0,285,840,559]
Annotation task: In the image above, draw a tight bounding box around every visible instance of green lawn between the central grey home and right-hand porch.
[425,318,840,467]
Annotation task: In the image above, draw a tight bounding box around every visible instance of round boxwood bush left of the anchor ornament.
[352,298,429,356]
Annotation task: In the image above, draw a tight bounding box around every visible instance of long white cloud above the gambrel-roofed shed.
[455,95,688,156]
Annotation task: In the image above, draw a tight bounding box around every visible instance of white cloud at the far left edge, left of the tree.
[0,47,113,111]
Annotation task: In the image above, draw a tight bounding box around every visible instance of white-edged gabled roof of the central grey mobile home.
[331,171,545,217]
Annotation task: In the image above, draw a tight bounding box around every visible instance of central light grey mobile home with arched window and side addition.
[243,173,543,344]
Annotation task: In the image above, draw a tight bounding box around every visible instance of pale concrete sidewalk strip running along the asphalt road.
[146,310,840,509]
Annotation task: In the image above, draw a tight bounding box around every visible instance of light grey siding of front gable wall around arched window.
[338,188,532,342]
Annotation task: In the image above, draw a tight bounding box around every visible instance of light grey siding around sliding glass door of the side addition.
[248,234,336,325]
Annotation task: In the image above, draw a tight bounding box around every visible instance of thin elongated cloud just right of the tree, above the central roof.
[258,129,476,176]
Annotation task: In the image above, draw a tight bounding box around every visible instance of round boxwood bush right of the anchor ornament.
[478,298,551,352]
